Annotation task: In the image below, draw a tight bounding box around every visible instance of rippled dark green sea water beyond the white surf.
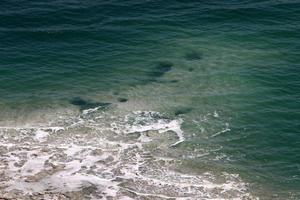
[0,0,300,199]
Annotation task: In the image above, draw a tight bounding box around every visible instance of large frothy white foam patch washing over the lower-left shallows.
[0,110,258,200]
